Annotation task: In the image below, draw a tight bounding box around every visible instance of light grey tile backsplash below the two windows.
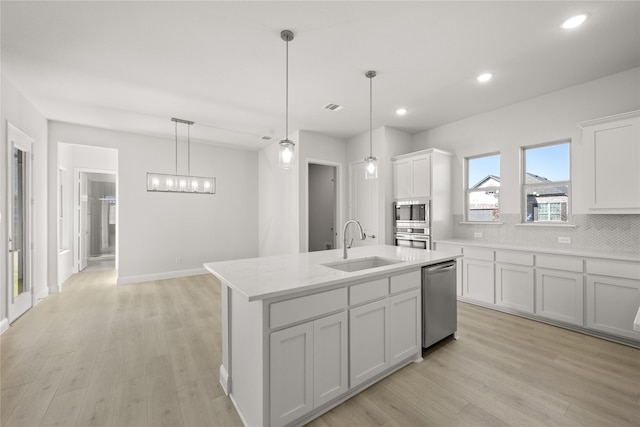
[453,214,640,254]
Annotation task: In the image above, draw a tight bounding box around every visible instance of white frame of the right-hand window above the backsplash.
[520,138,572,225]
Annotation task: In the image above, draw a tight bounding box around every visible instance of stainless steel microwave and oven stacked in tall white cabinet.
[393,199,431,249]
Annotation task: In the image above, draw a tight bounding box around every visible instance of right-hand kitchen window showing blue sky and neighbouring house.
[522,141,571,223]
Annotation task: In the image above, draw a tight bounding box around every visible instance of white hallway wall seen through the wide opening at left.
[57,142,119,287]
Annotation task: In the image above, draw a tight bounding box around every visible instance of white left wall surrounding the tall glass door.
[0,75,49,329]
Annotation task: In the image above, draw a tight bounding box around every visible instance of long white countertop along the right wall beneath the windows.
[434,239,640,262]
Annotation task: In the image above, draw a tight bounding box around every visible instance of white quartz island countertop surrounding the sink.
[204,245,461,301]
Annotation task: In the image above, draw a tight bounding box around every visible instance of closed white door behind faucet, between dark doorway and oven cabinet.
[347,161,382,246]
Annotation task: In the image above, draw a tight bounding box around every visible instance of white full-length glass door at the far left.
[7,124,33,323]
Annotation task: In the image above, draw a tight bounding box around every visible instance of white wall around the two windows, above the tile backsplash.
[413,68,640,215]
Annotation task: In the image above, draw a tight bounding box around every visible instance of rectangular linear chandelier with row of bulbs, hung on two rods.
[147,117,216,194]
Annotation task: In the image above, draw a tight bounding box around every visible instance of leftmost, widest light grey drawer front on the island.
[269,288,347,329]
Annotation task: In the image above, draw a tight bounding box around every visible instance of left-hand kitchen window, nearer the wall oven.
[465,154,500,222]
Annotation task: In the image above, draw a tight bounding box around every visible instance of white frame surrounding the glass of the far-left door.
[5,121,35,324]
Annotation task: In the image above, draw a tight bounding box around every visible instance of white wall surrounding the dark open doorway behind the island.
[298,131,349,252]
